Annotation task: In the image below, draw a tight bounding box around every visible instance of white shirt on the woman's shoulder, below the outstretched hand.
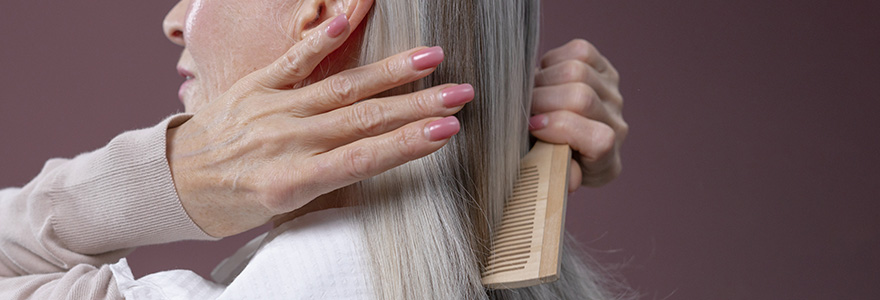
[111,208,373,300]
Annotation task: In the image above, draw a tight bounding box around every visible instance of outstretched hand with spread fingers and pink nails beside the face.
[168,18,474,237]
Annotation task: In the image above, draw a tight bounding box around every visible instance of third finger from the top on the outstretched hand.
[307,84,474,148]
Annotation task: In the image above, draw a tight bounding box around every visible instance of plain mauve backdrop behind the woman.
[0,0,880,299]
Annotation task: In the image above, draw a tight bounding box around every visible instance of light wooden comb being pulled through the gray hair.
[482,141,571,289]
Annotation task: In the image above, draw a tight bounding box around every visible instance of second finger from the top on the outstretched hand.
[294,47,444,116]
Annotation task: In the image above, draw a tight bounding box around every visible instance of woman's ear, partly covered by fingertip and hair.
[293,0,374,41]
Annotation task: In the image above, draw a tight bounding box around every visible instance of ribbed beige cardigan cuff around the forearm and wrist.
[44,115,212,254]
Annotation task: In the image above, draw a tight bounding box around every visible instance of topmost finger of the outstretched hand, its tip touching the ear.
[253,15,351,89]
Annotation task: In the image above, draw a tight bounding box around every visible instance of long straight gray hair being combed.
[348,0,632,299]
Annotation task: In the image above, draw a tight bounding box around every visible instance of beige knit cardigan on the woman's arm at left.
[0,115,212,299]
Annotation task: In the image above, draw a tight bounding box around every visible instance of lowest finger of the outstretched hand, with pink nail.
[315,117,461,195]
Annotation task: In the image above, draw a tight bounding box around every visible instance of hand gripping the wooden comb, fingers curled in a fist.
[529,40,629,192]
